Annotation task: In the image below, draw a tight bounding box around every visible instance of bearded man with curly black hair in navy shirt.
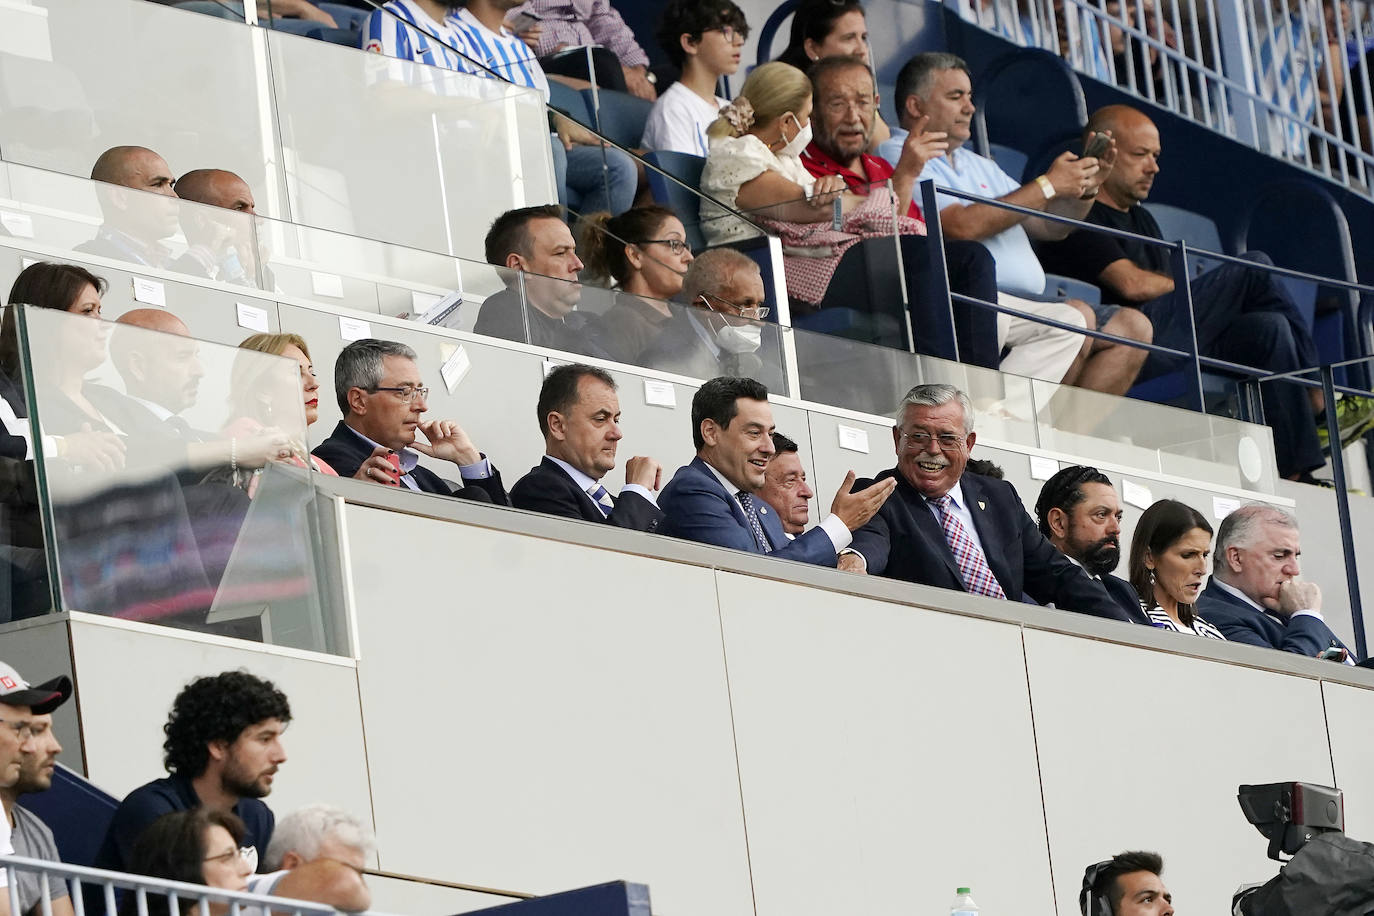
[93,670,291,872]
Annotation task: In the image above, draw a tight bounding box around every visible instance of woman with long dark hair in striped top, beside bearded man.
[1131,500,1226,640]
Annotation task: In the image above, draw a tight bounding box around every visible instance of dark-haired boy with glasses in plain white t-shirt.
[640,0,749,157]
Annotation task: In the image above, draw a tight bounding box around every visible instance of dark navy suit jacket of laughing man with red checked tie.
[849,468,1132,622]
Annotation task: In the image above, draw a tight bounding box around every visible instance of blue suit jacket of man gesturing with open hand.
[658,457,835,566]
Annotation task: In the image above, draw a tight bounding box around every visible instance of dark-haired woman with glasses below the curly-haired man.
[120,808,257,916]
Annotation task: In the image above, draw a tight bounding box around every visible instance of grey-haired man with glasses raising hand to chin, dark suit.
[312,338,510,505]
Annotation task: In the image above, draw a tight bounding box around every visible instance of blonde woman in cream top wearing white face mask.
[701,62,845,244]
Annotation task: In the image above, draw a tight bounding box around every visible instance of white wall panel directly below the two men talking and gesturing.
[717,573,1052,916]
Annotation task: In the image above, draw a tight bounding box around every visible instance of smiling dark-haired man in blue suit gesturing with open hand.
[658,378,893,566]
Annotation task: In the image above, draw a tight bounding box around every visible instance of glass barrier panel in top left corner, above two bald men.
[0,0,284,214]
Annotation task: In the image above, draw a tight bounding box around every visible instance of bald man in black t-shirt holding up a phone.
[1039,104,1325,479]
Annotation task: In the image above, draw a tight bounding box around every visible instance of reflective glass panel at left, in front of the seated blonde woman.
[15,306,338,651]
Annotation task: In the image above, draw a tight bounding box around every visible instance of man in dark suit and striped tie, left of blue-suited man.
[511,363,664,531]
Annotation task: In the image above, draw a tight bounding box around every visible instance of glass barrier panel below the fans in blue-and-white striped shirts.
[267,29,558,255]
